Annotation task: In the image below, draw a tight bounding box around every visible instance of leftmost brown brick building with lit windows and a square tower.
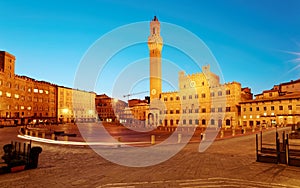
[0,51,57,125]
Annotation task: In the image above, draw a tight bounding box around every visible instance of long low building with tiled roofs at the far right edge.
[240,80,300,127]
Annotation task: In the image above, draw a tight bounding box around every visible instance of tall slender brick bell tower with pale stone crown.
[148,16,163,101]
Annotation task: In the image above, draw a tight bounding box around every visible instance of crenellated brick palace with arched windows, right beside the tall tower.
[159,65,252,127]
